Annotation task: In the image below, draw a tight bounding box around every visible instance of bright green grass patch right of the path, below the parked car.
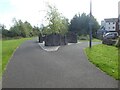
[85,44,120,80]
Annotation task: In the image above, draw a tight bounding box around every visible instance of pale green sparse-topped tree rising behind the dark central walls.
[43,4,68,34]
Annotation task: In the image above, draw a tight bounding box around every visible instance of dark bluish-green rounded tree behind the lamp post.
[69,13,99,37]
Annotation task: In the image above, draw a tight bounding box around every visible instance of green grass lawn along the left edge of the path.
[0,38,31,78]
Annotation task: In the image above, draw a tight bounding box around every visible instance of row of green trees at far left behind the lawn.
[0,19,40,38]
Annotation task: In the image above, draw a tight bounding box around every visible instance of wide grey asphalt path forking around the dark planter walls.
[2,40,118,88]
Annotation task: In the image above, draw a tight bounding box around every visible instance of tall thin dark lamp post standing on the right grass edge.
[89,0,92,48]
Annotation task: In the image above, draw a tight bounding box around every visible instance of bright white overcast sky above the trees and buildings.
[0,0,120,28]
